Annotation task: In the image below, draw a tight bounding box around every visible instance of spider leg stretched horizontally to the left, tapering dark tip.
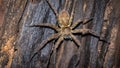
[29,23,59,32]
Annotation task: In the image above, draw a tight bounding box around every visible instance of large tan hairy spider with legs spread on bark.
[30,0,108,65]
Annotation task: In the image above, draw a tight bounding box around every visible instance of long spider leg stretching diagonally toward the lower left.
[30,33,60,61]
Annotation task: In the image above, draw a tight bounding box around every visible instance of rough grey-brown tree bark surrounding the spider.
[0,0,120,68]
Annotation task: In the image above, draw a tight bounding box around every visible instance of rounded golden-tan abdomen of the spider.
[58,10,70,27]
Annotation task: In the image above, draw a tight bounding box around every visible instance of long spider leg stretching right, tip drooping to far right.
[72,28,109,43]
